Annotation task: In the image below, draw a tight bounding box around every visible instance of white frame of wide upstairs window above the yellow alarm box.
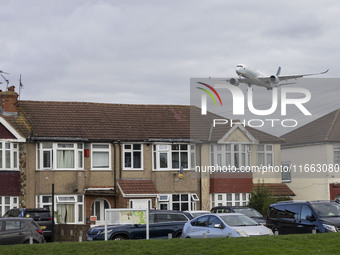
[152,143,196,171]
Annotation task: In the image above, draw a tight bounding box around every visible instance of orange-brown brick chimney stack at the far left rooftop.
[0,86,19,115]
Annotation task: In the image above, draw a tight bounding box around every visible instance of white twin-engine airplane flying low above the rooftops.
[210,64,329,90]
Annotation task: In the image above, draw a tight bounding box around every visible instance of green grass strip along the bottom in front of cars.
[0,233,340,255]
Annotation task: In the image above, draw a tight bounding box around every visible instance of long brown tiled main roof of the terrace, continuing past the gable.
[1,101,281,143]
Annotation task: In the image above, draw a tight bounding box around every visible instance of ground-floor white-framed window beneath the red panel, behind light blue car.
[210,192,250,207]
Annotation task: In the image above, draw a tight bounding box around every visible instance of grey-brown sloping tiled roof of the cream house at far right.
[282,109,340,147]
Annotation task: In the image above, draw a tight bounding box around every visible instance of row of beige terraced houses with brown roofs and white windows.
[0,87,340,240]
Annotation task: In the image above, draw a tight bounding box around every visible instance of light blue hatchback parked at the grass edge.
[182,213,273,238]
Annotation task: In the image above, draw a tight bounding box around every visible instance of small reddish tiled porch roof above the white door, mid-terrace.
[118,180,159,195]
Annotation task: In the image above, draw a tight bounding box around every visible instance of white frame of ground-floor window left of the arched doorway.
[36,195,85,224]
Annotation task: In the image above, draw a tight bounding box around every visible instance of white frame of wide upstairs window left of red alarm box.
[36,142,84,171]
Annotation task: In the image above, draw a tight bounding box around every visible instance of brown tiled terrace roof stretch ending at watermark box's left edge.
[12,101,189,140]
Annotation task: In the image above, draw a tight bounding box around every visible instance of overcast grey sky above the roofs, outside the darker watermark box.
[0,0,340,135]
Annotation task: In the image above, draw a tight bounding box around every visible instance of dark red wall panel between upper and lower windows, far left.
[0,171,20,196]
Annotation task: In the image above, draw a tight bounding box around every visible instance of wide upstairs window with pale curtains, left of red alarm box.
[37,142,84,170]
